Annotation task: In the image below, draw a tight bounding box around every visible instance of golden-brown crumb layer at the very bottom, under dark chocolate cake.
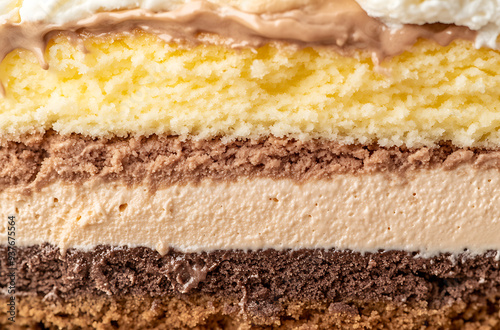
[0,296,500,330]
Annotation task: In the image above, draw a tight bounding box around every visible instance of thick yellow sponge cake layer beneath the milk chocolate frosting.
[0,34,500,146]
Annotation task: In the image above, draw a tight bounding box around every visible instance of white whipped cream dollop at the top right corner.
[357,0,500,48]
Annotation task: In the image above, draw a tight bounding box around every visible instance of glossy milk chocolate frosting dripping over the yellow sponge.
[0,0,476,67]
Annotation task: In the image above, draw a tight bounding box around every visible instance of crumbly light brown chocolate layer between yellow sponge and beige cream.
[0,131,500,190]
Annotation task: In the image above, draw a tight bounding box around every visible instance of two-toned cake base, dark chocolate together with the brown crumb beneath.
[0,245,500,329]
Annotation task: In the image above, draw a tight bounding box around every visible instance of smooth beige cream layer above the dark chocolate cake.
[0,167,500,255]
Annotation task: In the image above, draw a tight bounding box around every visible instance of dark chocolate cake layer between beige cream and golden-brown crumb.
[0,245,500,315]
